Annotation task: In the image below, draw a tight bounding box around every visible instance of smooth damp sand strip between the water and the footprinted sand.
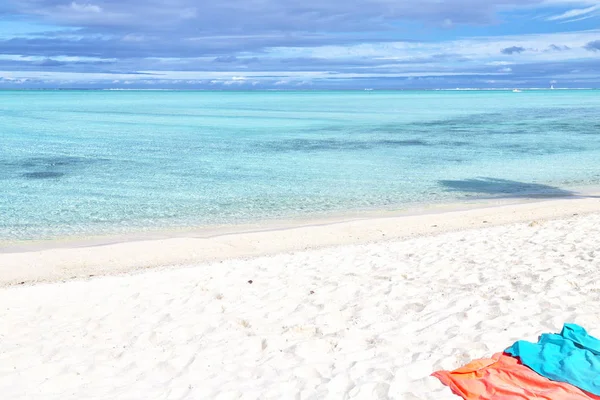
[0,193,600,287]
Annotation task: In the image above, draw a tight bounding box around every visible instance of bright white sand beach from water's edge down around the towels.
[0,197,600,400]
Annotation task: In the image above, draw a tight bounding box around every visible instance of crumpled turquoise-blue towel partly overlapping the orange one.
[506,324,600,396]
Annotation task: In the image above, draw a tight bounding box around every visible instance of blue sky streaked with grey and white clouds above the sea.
[0,0,600,90]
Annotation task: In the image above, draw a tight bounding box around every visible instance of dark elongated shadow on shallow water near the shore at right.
[439,178,589,199]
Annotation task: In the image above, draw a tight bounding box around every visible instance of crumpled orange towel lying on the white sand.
[432,353,600,400]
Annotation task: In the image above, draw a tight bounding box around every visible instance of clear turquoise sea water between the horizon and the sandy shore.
[0,91,600,240]
